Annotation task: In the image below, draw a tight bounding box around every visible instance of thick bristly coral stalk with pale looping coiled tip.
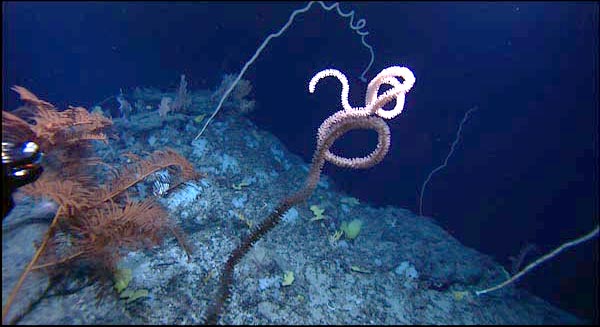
[206,66,415,325]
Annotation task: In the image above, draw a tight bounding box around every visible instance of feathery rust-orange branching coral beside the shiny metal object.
[2,86,200,323]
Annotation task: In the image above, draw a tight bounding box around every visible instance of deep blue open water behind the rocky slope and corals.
[2,2,599,323]
